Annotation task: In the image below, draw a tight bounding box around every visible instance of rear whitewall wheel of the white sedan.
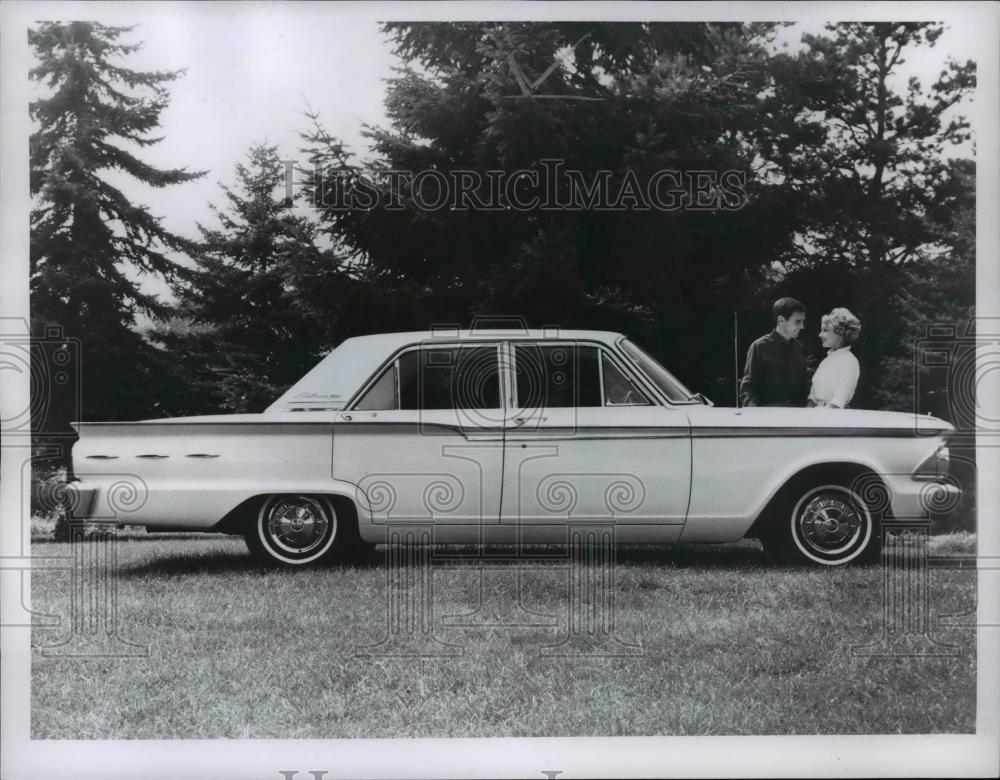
[245,496,338,567]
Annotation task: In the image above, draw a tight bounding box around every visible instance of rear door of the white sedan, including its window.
[333,343,505,541]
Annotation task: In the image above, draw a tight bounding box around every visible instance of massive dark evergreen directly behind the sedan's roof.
[306,22,819,402]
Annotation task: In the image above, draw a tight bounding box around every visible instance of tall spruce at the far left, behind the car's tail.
[28,22,203,428]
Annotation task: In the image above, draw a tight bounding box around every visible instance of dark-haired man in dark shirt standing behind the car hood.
[740,298,809,406]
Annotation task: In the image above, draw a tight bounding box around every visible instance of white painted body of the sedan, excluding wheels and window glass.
[72,331,957,564]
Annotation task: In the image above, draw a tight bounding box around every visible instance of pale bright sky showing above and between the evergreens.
[21,3,969,306]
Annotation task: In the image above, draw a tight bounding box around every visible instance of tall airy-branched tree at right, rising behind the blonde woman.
[780,22,976,406]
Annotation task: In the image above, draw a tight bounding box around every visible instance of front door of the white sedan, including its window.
[501,341,691,541]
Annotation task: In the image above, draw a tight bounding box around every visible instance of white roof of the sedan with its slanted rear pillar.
[266,327,622,413]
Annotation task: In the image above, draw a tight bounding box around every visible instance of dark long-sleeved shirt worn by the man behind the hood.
[740,330,809,406]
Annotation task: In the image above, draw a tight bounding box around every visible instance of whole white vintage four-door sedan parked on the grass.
[71,330,960,567]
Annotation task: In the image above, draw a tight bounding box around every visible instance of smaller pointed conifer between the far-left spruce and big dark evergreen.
[157,144,342,412]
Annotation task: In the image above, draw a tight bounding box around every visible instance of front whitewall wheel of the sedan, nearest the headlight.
[764,484,881,566]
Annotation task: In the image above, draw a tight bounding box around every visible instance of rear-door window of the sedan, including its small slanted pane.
[355,345,500,410]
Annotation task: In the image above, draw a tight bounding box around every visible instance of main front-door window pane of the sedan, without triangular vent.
[514,344,601,409]
